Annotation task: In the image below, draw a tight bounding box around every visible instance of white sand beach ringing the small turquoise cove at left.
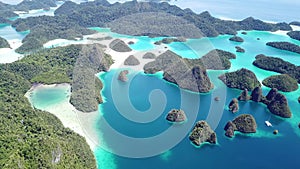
[24,83,100,152]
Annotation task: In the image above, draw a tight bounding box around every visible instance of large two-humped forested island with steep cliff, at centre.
[144,49,236,93]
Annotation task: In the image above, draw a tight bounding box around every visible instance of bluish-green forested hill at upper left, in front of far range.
[12,16,94,53]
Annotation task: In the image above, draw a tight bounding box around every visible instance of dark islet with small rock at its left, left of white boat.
[224,114,257,138]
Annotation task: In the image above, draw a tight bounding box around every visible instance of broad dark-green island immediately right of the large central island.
[219,68,261,91]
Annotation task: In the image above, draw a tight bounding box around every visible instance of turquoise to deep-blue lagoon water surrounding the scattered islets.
[29,31,300,169]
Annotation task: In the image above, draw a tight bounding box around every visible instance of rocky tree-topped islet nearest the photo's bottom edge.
[189,120,217,146]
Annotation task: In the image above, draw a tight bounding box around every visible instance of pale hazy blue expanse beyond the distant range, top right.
[0,0,300,22]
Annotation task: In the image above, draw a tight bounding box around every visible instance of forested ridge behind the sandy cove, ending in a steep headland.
[0,45,113,112]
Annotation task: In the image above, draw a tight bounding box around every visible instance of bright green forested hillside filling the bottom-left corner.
[0,70,96,169]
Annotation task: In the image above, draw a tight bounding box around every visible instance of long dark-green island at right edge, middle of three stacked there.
[253,54,300,83]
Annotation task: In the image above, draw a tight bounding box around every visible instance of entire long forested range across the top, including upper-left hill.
[0,0,292,53]
